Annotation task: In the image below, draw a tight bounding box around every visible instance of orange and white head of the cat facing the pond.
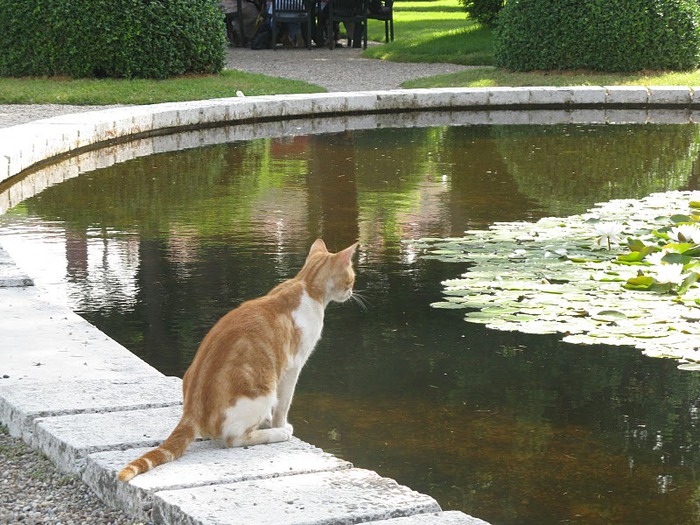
[301,239,358,304]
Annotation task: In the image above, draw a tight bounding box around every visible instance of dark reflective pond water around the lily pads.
[0,125,700,525]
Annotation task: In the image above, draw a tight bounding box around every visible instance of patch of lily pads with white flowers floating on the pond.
[414,192,700,369]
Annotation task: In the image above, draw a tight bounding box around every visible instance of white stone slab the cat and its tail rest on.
[83,438,352,520]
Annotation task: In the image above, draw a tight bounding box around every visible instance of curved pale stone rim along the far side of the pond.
[0,86,700,188]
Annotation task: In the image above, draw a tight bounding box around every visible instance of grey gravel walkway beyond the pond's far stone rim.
[0,47,468,128]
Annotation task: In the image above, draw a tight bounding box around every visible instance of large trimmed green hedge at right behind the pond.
[494,0,700,72]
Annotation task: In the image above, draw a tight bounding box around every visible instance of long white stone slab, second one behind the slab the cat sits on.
[0,376,182,443]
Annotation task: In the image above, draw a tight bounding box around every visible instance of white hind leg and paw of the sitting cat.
[221,394,292,447]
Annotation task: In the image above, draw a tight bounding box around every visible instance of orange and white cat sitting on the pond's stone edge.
[118,239,357,481]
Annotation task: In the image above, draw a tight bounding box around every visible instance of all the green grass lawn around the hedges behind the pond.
[0,0,700,105]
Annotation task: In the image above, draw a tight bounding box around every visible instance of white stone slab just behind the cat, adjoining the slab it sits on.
[32,406,182,473]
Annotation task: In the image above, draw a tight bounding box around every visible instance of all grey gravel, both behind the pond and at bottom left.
[0,48,465,525]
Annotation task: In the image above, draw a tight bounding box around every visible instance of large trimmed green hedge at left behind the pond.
[0,0,225,78]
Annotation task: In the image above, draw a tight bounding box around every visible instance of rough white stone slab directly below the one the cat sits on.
[152,469,440,525]
